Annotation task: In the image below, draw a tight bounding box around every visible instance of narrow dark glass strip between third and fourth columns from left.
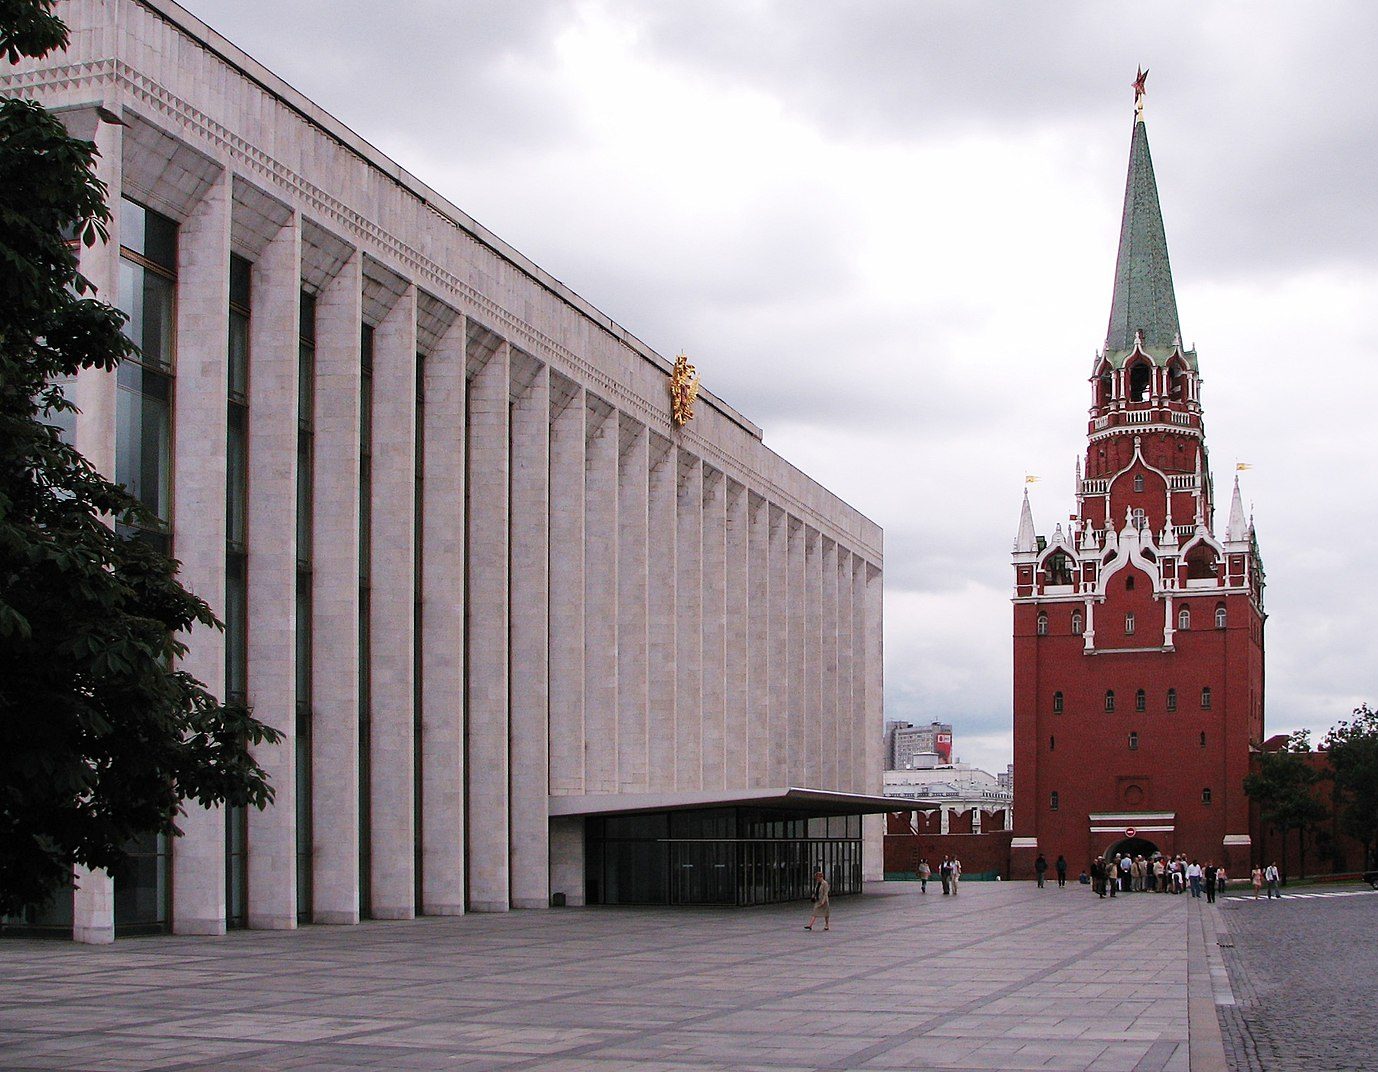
[296,291,316,923]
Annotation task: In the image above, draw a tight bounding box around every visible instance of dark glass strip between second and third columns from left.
[225,254,251,927]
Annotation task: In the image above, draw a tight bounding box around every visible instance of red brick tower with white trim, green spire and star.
[1011,81,1265,876]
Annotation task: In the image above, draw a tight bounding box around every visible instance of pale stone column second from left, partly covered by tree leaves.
[172,171,232,934]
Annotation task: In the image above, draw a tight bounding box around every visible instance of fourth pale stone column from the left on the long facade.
[311,252,364,923]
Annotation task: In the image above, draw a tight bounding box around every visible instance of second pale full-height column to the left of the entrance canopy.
[466,342,511,912]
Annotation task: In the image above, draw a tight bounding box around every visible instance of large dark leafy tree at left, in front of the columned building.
[0,0,281,914]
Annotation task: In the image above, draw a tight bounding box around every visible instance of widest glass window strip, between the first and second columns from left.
[114,198,176,933]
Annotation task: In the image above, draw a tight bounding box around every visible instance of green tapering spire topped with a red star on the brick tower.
[1105,72,1181,354]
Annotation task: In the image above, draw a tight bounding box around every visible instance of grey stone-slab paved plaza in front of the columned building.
[0,882,1225,1072]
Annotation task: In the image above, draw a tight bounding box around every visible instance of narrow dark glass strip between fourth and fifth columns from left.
[358,324,373,919]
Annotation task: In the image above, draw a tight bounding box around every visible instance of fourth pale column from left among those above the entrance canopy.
[646,435,679,791]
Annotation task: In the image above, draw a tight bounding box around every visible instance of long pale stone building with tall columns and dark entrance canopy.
[0,0,883,941]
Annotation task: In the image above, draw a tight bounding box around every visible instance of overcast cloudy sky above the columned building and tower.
[190,0,1378,770]
